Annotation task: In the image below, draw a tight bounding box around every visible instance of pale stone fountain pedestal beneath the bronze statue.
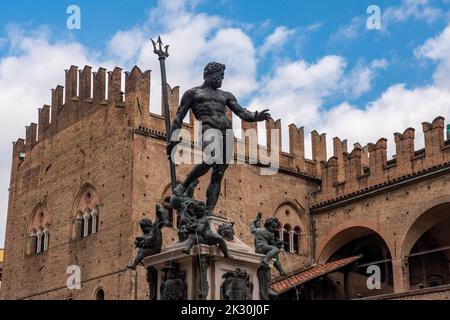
[143,216,263,300]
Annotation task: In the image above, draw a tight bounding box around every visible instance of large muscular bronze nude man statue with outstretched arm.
[167,62,271,215]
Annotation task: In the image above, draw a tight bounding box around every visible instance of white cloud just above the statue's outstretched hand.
[250,56,387,132]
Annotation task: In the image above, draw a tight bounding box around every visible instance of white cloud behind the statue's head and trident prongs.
[105,0,256,113]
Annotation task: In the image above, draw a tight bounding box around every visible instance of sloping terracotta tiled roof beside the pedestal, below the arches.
[270,256,361,294]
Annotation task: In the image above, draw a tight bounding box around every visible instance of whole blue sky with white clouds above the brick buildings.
[0,0,450,246]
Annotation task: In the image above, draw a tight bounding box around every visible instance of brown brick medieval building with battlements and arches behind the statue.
[1,66,450,299]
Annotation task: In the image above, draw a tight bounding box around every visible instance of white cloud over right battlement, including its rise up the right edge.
[314,25,450,155]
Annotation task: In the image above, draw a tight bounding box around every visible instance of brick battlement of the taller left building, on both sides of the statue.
[14,66,336,181]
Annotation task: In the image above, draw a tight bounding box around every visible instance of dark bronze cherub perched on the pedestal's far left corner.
[128,204,168,269]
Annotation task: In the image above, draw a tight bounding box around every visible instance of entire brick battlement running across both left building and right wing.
[13,66,450,194]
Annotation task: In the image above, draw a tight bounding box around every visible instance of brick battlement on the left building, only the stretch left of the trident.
[14,66,150,160]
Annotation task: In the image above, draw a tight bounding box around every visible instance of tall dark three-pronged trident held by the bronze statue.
[151,37,177,193]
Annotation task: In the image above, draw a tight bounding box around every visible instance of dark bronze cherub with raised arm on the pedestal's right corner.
[250,212,286,276]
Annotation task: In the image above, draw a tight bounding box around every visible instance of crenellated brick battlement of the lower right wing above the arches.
[313,117,450,207]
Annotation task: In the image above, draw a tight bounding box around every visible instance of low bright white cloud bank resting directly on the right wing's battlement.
[316,84,450,156]
